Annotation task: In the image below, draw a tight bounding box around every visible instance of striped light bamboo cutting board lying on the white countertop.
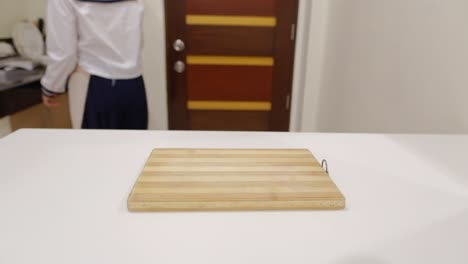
[128,149,345,212]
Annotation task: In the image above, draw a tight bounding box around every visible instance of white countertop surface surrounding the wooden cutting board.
[0,130,468,264]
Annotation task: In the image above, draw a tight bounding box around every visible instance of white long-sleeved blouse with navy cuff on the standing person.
[41,0,144,96]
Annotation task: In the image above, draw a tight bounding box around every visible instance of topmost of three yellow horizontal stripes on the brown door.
[185,15,276,27]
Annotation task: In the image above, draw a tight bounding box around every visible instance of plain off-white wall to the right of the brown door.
[302,0,468,133]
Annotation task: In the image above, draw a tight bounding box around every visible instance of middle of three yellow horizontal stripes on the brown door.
[187,55,275,67]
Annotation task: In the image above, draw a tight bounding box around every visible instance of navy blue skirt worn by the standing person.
[82,76,148,130]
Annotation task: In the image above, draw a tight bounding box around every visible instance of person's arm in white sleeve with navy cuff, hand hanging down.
[41,0,78,107]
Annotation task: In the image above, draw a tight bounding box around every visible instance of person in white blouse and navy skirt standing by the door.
[41,0,148,129]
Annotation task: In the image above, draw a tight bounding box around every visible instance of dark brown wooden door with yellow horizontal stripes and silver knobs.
[165,0,298,131]
